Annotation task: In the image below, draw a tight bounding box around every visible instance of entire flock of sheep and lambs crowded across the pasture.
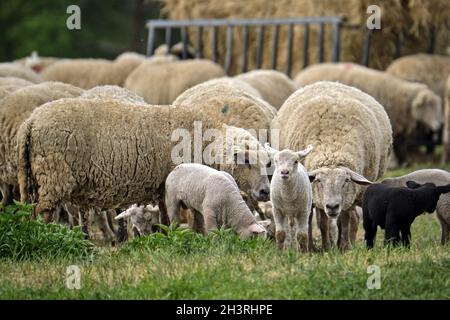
[0,46,450,252]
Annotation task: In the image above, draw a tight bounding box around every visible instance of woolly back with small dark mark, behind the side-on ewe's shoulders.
[173,79,276,133]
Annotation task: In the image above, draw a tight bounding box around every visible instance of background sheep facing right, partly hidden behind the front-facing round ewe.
[294,63,442,164]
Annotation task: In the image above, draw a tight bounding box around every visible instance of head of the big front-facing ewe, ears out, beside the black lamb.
[309,167,372,218]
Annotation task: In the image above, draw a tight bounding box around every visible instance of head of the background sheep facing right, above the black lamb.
[412,88,443,131]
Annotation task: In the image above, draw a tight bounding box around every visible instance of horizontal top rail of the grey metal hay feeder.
[147,16,342,27]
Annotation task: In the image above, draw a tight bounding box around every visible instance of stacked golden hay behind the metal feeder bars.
[164,0,450,74]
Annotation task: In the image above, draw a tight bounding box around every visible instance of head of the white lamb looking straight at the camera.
[265,143,313,181]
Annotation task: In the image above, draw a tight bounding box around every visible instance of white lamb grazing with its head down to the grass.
[166,163,266,240]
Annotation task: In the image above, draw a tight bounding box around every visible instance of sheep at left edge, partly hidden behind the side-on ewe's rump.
[0,82,82,206]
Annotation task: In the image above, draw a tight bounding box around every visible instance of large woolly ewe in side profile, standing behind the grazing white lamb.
[18,98,269,223]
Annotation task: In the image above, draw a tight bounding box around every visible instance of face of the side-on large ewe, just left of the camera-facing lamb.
[232,150,270,201]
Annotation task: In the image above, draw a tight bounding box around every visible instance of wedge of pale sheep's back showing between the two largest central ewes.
[235,70,299,110]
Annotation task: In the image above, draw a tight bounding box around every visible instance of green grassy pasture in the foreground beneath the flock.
[0,165,450,299]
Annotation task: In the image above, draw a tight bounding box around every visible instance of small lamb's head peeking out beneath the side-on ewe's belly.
[115,204,160,235]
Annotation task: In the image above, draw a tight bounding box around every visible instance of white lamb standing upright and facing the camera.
[265,143,313,252]
